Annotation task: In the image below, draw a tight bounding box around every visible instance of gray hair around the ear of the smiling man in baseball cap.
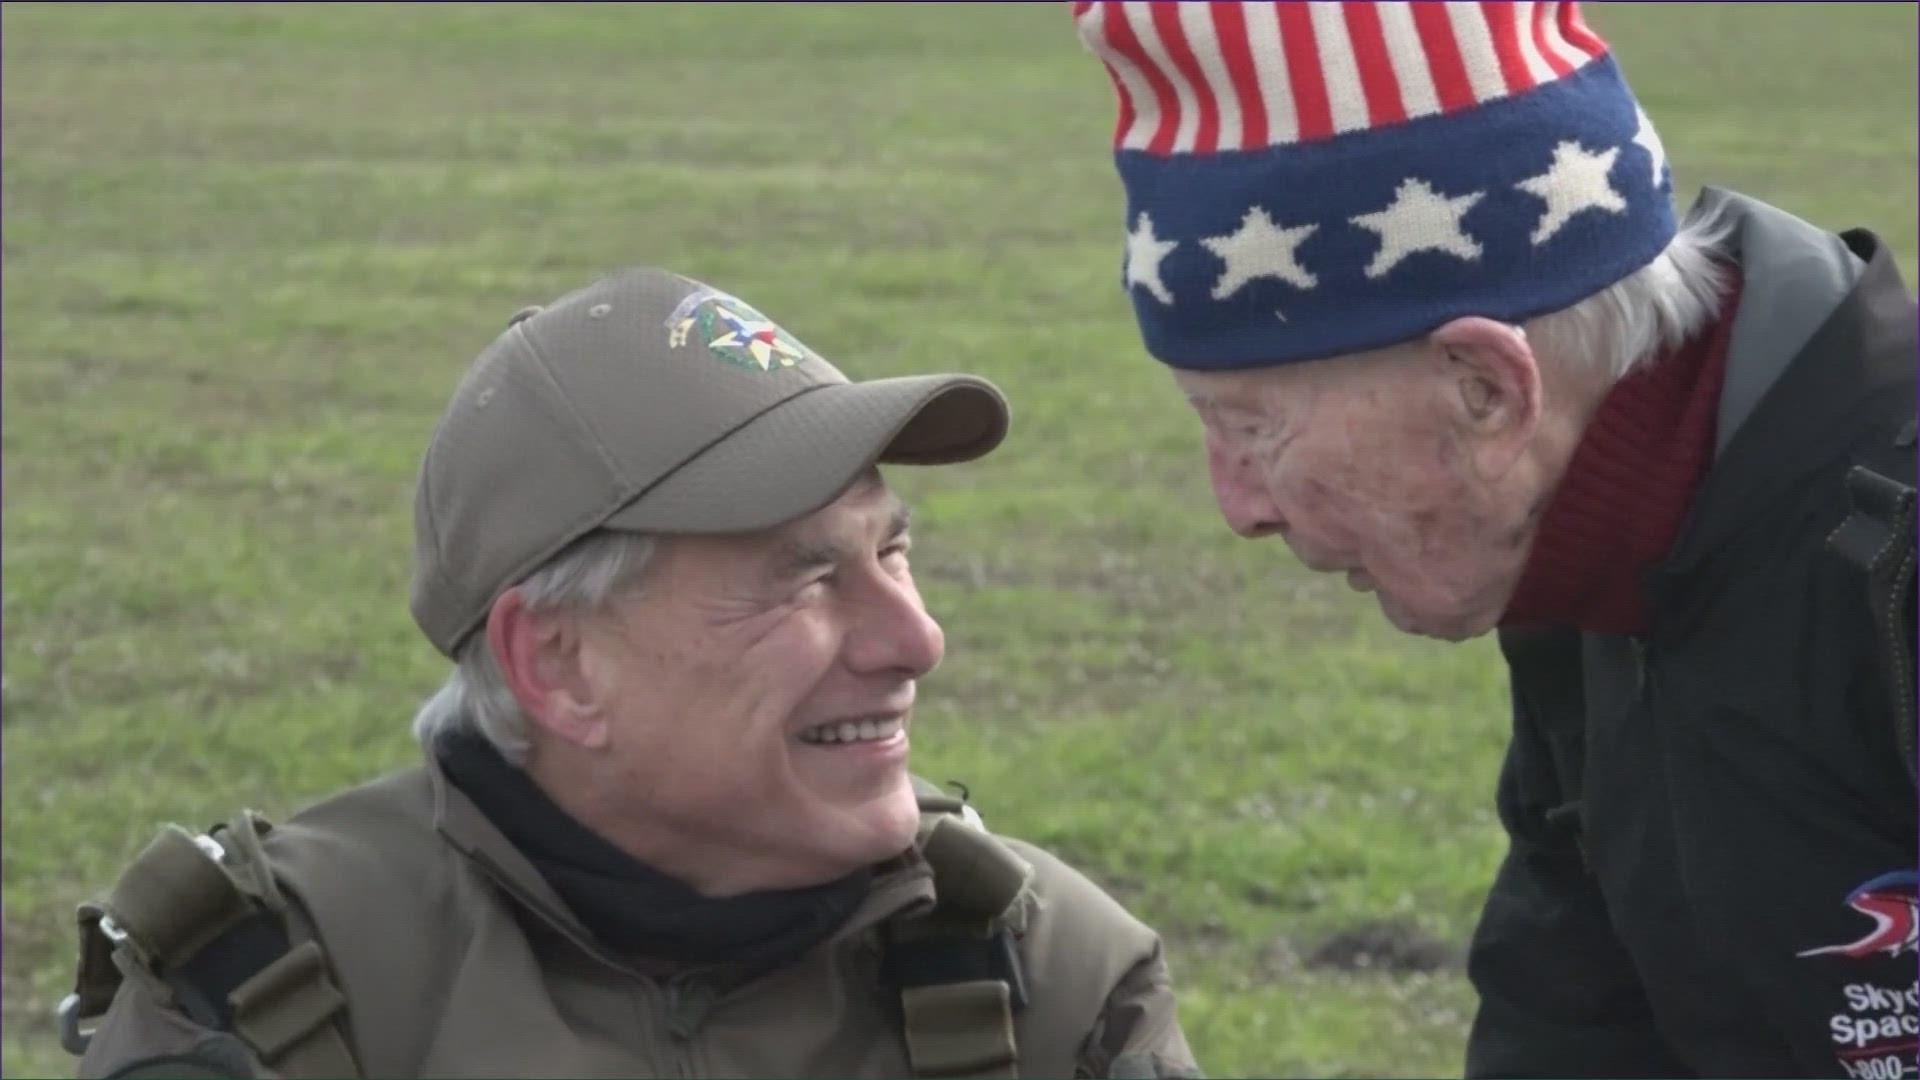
[413,530,653,765]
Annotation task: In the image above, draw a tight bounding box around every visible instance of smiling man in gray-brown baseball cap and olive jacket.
[63,269,1196,1076]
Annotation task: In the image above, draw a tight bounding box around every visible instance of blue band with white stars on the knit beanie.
[1116,56,1674,371]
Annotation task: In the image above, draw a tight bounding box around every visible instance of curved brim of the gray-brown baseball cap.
[605,375,1008,534]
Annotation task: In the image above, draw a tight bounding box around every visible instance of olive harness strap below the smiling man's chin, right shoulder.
[883,778,1033,1076]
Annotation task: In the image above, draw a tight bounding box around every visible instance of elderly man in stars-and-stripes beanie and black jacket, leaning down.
[1075,4,1920,1078]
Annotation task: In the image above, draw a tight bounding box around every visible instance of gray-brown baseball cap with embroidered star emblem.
[413,267,1008,657]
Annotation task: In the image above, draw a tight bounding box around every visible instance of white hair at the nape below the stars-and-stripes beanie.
[1523,199,1734,380]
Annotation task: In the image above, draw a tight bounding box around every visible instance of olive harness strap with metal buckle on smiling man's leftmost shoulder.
[60,811,359,1076]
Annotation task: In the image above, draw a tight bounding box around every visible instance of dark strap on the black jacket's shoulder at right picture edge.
[1826,421,1920,786]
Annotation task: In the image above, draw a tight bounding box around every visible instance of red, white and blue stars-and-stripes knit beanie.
[1073,0,1674,371]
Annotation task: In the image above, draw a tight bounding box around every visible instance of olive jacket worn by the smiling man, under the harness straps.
[81,761,1198,1078]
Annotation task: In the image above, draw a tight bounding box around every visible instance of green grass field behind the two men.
[0,4,1916,1076]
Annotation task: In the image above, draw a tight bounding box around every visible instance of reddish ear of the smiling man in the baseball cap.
[486,588,607,749]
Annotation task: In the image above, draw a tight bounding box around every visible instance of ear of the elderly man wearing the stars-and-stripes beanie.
[1427,317,1542,480]
